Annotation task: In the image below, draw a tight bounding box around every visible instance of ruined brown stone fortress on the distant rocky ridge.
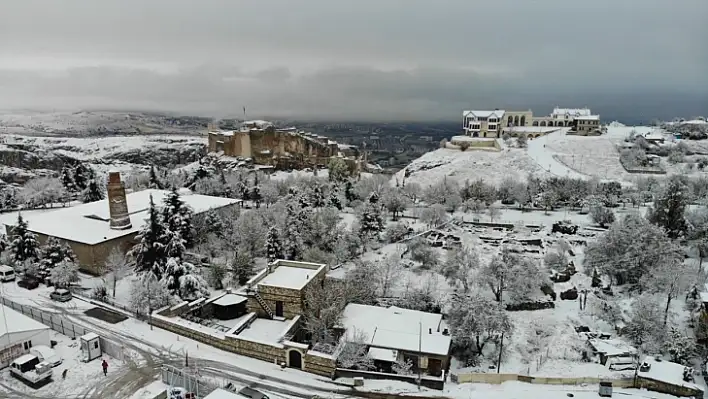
[208,121,363,172]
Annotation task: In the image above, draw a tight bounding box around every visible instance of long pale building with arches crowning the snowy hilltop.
[462,107,601,139]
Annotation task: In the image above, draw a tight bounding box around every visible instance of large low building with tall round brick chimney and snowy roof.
[6,172,240,274]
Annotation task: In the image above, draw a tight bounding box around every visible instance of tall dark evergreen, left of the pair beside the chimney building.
[129,195,167,280]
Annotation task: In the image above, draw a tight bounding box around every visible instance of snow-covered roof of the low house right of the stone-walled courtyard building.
[342,304,450,356]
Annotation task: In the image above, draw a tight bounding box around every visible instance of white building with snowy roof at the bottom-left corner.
[0,305,51,368]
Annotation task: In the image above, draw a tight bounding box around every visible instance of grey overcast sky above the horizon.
[0,0,708,120]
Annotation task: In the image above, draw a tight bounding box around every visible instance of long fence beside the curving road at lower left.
[2,297,125,361]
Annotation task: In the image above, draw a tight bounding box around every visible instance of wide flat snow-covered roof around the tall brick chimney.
[10,190,240,245]
